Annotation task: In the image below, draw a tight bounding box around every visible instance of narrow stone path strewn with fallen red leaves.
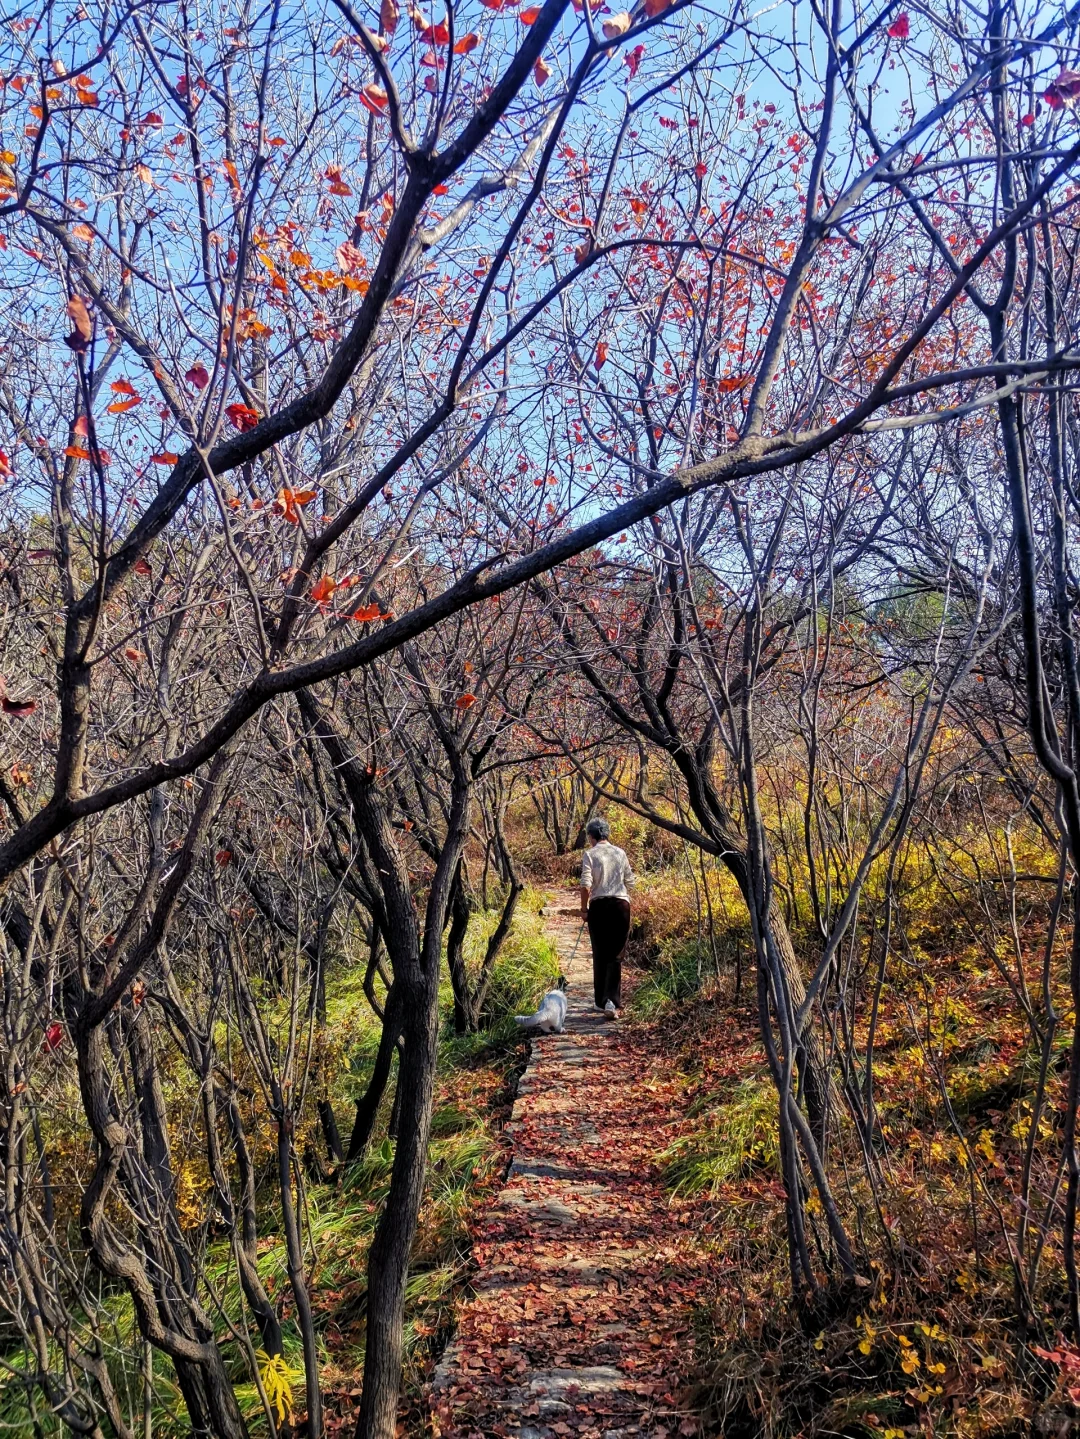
[431,896,709,1439]
